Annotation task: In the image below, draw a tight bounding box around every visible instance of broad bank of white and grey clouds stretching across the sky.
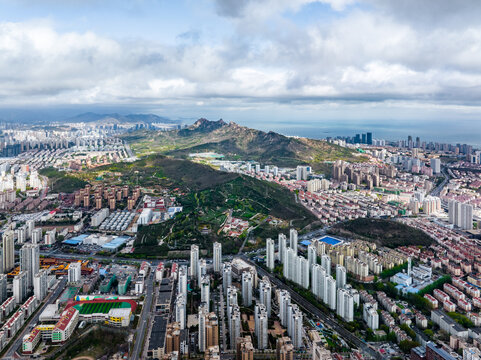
[0,0,481,112]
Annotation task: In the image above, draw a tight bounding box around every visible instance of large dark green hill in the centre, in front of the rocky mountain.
[101,155,316,257]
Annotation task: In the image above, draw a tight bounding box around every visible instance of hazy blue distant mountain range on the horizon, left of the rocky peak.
[63,112,180,124]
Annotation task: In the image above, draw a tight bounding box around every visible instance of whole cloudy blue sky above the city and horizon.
[0,0,481,126]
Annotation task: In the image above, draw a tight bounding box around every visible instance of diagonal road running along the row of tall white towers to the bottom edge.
[241,255,382,359]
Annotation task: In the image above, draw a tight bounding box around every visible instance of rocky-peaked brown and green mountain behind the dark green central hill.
[124,119,364,169]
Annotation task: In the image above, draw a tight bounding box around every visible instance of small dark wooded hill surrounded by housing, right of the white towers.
[330,218,433,248]
